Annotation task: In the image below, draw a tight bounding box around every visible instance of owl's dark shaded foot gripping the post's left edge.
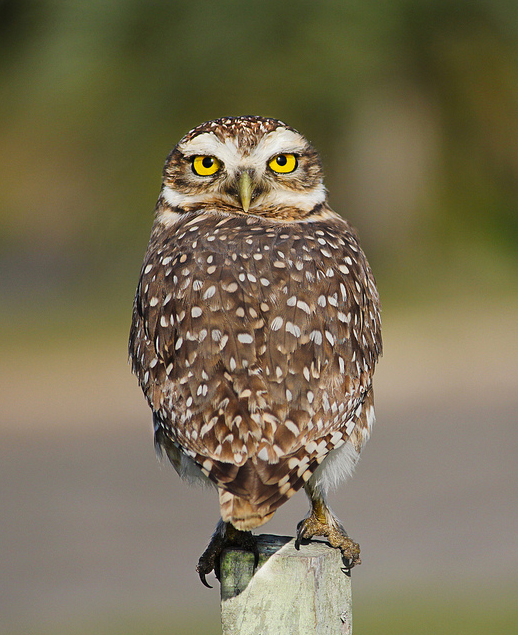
[196,520,259,589]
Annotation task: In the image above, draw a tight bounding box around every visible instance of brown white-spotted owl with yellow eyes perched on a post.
[129,116,382,584]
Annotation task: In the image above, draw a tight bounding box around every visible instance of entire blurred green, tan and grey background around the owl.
[0,0,518,635]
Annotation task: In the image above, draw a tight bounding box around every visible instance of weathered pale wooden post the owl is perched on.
[221,534,352,635]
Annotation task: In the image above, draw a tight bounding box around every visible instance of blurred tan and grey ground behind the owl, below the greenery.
[0,303,518,633]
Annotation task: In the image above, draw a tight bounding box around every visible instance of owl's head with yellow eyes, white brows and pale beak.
[161,117,326,220]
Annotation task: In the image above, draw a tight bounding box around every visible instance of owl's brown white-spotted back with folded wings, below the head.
[134,209,377,459]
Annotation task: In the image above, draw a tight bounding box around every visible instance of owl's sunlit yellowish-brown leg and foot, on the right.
[295,478,361,567]
